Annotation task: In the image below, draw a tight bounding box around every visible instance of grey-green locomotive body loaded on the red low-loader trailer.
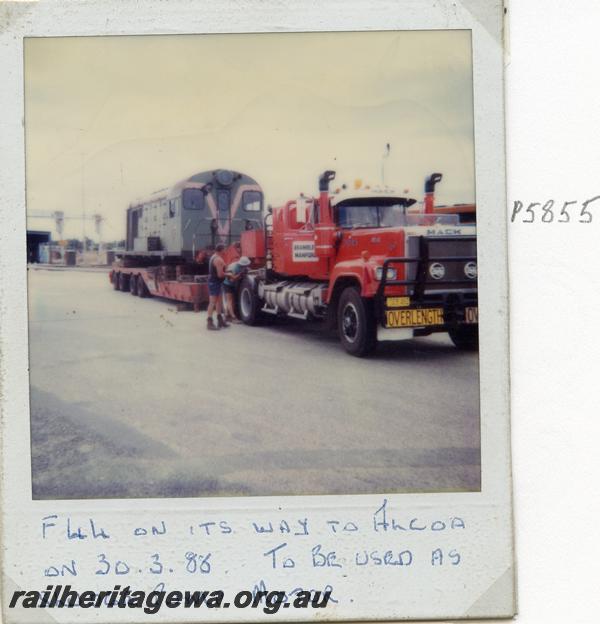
[124,169,263,262]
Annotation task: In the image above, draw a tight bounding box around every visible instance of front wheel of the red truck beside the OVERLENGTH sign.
[337,287,377,357]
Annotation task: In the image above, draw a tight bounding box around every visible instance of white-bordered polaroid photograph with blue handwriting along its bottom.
[0,0,516,623]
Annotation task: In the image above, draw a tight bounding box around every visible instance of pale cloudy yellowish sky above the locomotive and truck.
[25,31,475,241]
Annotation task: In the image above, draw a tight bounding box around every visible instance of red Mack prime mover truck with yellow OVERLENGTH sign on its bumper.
[237,171,478,357]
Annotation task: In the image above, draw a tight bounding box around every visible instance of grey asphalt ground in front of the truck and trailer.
[29,267,480,499]
